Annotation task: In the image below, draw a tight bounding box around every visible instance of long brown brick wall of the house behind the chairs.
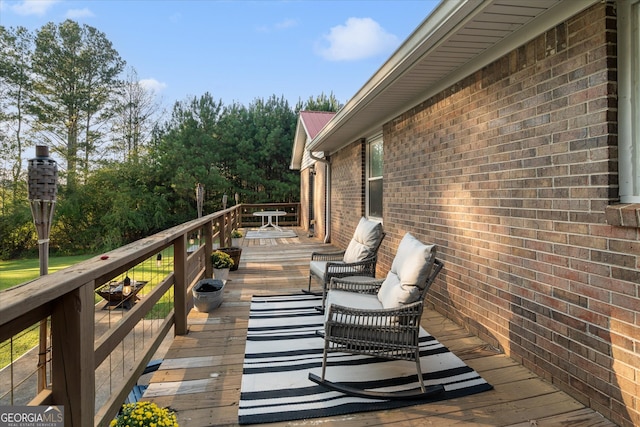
[332,3,640,425]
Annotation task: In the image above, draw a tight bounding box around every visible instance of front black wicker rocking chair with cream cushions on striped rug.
[309,234,444,399]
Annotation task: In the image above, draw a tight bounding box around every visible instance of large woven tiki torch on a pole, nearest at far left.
[28,145,58,391]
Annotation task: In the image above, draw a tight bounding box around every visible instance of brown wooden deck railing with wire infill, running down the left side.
[0,203,299,426]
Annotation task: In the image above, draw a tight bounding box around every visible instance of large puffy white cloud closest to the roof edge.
[316,18,400,61]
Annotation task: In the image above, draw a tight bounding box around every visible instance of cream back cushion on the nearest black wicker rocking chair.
[378,233,436,308]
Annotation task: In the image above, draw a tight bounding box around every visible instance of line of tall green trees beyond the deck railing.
[0,20,341,259]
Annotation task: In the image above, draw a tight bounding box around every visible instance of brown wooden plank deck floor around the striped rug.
[144,230,615,427]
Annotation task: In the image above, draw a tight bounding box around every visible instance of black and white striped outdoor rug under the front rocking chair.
[238,294,492,424]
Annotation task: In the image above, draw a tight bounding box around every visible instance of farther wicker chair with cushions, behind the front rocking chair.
[302,217,385,307]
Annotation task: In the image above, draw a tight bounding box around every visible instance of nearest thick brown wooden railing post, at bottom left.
[51,281,95,427]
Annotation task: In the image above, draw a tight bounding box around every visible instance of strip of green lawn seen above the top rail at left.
[0,255,94,291]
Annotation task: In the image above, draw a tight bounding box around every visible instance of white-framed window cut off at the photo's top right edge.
[618,0,640,203]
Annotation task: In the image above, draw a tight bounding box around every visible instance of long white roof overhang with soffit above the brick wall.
[309,0,598,152]
